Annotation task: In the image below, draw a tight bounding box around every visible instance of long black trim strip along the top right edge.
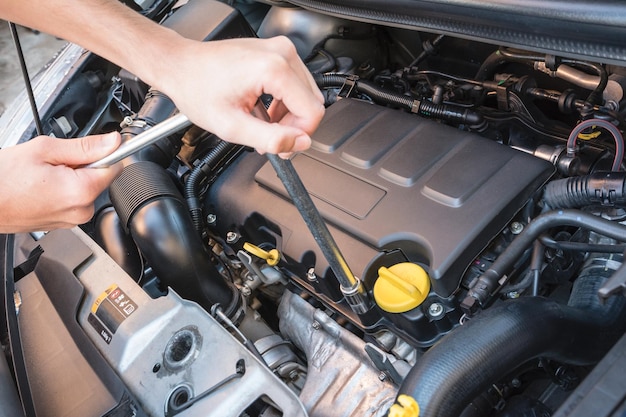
[289,0,626,64]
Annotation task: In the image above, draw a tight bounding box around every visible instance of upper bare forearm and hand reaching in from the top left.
[0,0,324,153]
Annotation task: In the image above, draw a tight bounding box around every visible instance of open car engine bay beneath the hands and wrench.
[0,0,626,417]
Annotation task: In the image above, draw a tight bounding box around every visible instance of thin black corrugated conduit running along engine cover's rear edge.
[313,74,486,131]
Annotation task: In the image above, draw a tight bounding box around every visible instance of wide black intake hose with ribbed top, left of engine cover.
[110,161,240,317]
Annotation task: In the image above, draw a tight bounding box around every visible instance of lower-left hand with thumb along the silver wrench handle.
[0,132,121,233]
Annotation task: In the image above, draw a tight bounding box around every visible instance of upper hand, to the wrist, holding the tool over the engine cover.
[155,37,324,154]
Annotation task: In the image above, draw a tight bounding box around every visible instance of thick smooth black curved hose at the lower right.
[399,268,626,417]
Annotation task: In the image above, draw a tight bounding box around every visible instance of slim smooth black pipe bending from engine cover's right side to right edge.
[461,209,626,315]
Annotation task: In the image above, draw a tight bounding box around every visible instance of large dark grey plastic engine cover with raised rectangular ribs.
[209,99,554,297]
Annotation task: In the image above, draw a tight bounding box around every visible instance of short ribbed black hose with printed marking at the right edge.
[543,171,626,209]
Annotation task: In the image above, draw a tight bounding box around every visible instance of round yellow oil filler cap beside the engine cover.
[374,262,430,313]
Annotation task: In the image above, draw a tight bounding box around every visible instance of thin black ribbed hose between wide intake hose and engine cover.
[184,141,239,232]
